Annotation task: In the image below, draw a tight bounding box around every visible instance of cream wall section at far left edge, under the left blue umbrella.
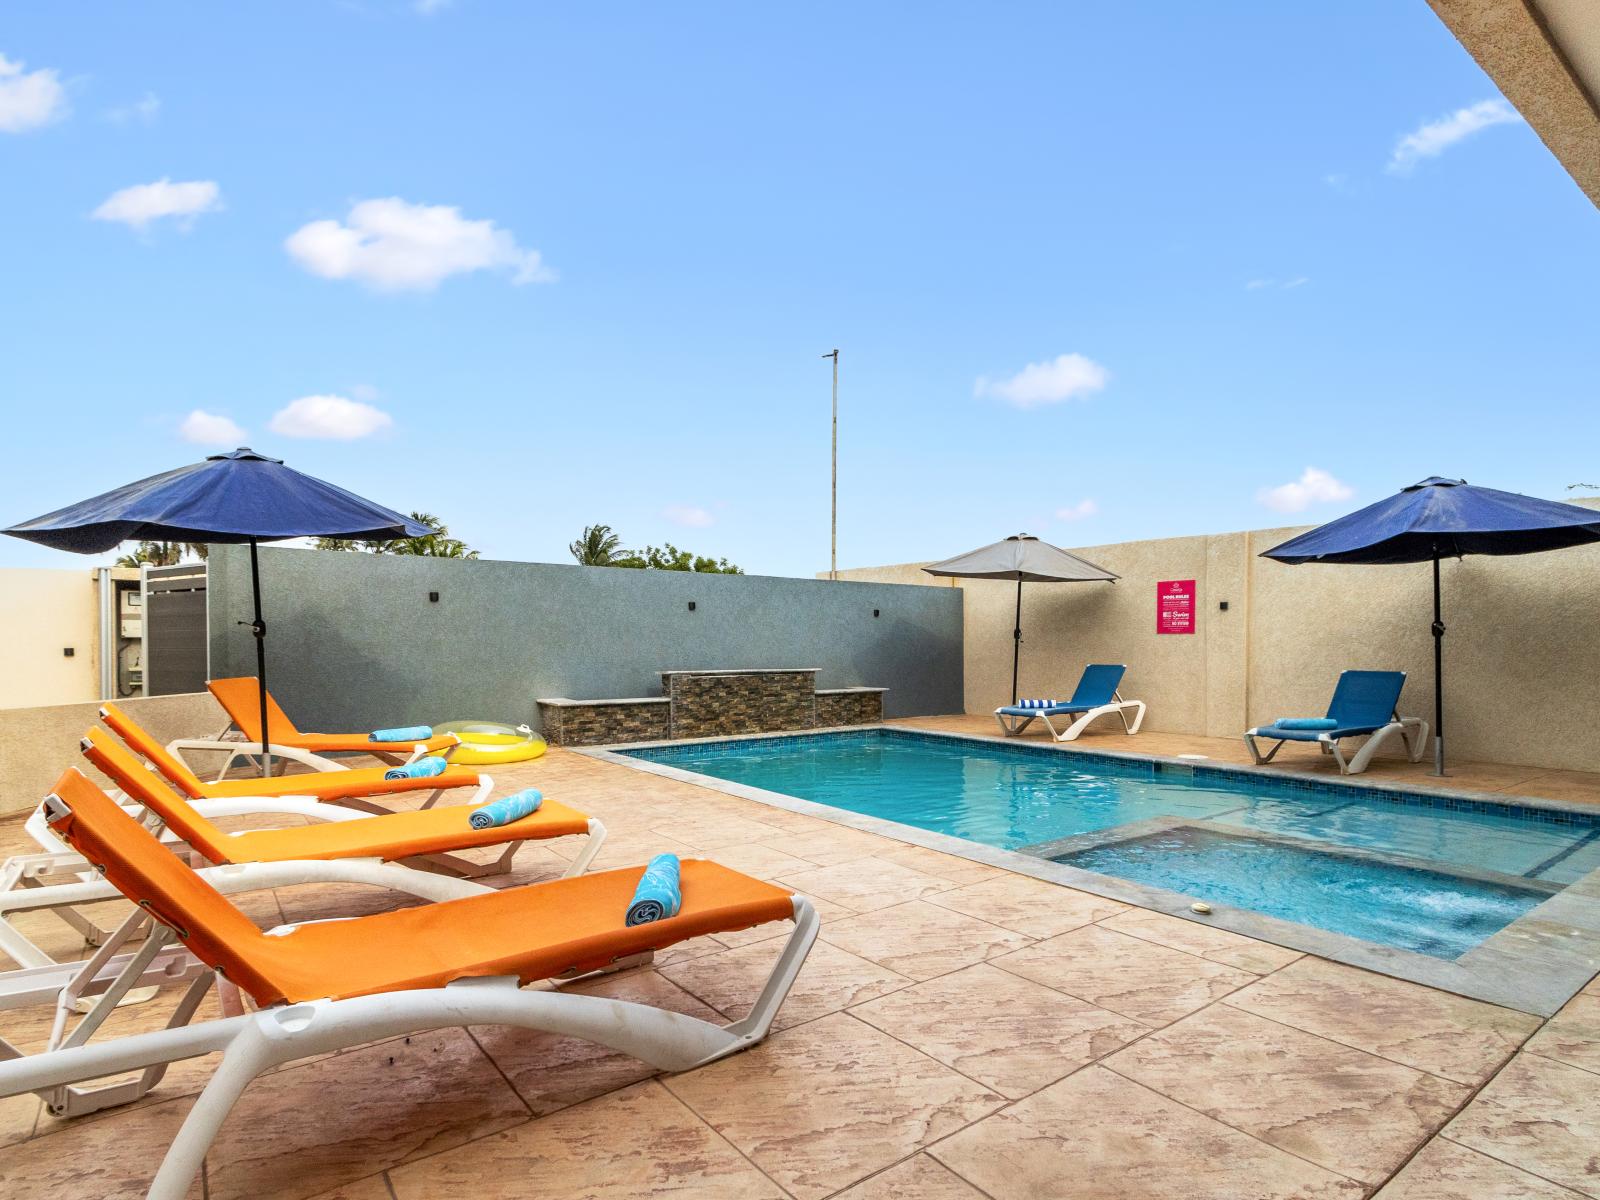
[0,566,99,709]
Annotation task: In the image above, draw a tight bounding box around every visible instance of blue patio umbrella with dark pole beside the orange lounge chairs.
[3,448,432,770]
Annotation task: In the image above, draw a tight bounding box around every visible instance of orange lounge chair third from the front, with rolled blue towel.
[101,704,480,813]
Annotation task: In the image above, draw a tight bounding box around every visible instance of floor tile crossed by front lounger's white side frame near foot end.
[472,970,723,1117]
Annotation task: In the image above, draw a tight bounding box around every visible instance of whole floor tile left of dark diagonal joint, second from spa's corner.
[1106,1005,1470,1184]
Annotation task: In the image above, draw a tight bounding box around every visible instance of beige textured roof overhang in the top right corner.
[1427,0,1600,205]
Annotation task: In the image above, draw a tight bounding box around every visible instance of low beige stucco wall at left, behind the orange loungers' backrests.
[0,691,227,813]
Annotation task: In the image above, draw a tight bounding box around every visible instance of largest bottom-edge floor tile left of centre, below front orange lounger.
[389,1083,782,1200]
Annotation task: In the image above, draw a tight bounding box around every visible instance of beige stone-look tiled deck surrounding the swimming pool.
[0,717,1600,1200]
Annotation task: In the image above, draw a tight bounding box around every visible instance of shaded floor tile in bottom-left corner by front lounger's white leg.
[0,1098,202,1200]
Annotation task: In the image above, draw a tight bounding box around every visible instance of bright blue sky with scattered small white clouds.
[0,0,1600,574]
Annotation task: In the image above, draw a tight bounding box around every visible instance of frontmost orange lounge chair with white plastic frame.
[0,770,818,1200]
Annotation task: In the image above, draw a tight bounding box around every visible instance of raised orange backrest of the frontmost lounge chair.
[45,768,283,1005]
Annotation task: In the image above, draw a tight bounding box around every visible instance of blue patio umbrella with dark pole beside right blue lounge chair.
[1261,475,1600,774]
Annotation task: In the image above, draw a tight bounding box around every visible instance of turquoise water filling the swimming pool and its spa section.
[626,730,1600,958]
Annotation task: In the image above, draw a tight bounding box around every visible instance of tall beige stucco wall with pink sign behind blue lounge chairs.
[840,501,1600,771]
